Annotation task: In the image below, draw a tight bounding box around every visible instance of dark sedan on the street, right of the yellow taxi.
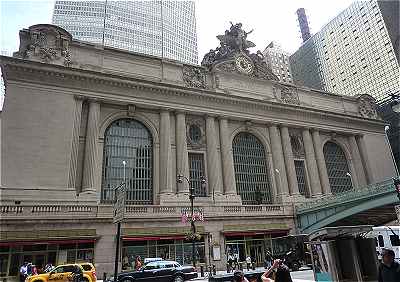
[108,260,197,282]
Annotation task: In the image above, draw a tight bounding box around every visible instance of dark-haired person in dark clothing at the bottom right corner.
[378,249,400,282]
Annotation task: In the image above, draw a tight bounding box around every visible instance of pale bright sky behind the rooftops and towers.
[0,0,353,109]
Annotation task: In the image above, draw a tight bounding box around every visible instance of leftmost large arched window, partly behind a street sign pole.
[101,119,153,205]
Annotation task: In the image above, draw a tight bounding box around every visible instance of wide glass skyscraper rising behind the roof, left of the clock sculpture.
[53,0,198,64]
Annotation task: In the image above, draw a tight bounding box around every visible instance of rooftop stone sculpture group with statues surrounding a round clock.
[201,23,278,80]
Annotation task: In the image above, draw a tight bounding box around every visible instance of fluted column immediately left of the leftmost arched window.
[82,100,100,192]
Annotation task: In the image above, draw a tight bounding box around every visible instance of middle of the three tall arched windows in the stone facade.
[232,132,272,205]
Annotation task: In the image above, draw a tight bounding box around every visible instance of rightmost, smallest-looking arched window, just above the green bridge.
[324,141,352,194]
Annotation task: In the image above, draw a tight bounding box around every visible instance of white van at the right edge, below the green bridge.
[372,226,400,262]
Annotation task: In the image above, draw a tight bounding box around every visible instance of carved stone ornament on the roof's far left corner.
[14,24,72,66]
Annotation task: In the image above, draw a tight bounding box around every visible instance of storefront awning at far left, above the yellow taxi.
[0,229,98,246]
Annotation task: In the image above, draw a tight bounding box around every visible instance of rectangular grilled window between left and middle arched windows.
[189,153,207,197]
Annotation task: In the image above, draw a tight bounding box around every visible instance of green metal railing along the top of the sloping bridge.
[296,179,394,214]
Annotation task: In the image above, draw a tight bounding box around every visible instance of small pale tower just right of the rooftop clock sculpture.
[262,41,292,82]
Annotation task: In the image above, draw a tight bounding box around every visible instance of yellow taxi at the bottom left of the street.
[25,264,96,282]
